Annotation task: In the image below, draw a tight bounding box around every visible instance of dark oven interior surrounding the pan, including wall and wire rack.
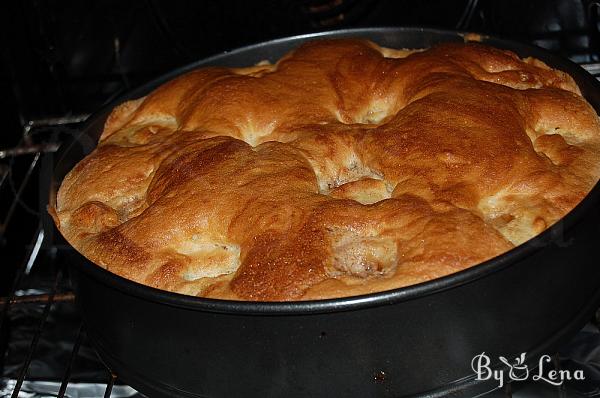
[0,0,600,397]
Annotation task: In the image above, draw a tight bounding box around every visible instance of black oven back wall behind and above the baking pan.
[0,0,598,141]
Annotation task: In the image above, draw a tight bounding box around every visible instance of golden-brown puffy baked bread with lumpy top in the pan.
[50,40,600,301]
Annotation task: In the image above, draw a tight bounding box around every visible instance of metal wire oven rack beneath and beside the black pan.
[0,64,600,398]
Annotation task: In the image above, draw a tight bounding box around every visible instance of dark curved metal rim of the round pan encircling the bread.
[50,27,600,315]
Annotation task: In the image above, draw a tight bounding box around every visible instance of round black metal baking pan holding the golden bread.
[51,28,600,398]
